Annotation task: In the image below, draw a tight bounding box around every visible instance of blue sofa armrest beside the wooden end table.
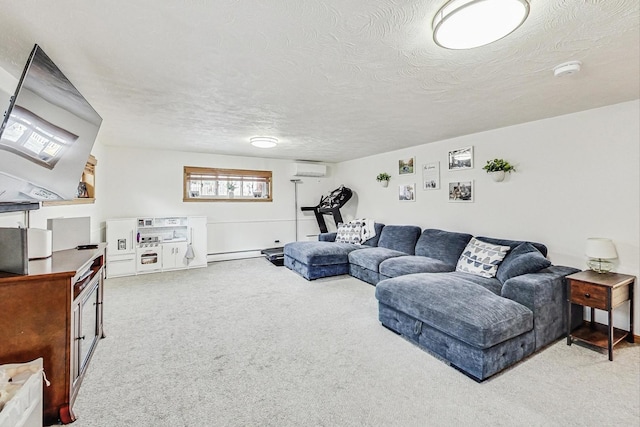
[502,266,582,350]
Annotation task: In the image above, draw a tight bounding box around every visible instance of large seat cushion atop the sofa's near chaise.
[376,273,533,349]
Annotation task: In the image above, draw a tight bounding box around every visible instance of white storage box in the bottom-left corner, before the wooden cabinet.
[0,358,43,427]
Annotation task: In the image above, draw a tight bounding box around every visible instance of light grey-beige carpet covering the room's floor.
[66,258,640,427]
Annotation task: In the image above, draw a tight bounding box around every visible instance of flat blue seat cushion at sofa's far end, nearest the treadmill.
[284,242,362,265]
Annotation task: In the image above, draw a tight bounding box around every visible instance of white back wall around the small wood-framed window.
[103,147,337,260]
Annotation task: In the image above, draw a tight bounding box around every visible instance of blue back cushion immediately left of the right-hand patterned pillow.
[416,228,472,267]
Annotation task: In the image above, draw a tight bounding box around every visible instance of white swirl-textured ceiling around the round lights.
[0,0,640,162]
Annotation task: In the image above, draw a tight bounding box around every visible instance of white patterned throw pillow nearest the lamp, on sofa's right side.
[456,237,511,277]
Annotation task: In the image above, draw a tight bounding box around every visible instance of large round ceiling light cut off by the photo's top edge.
[432,0,529,49]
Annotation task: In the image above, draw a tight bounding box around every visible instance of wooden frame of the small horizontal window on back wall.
[182,166,273,203]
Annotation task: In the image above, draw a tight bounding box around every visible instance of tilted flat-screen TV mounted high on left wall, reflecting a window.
[0,44,102,203]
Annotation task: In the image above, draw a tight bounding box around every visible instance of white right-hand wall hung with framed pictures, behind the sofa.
[336,101,640,334]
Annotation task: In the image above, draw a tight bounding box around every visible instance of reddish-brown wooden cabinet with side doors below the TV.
[0,244,106,425]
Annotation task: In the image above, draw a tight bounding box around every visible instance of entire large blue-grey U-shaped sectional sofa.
[284,224,581,381]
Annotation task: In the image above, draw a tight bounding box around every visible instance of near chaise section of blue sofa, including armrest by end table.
[376,266,580,381]
